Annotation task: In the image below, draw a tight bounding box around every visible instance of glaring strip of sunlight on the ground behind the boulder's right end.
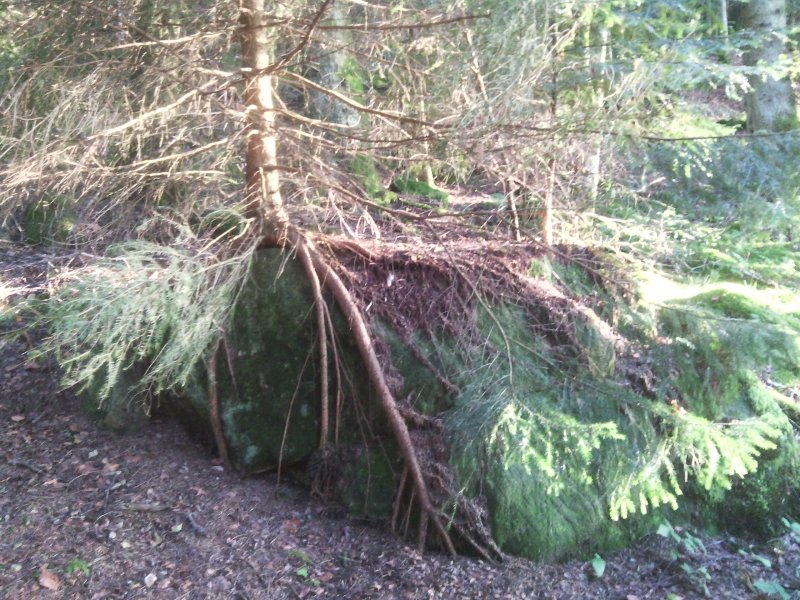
[640,271,800,314]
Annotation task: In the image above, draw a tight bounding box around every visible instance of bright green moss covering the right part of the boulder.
[447,280,798,560]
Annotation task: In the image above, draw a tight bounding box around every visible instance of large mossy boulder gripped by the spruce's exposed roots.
[73,245,800,560]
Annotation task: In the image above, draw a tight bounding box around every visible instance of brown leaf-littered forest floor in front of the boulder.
[0,245,800,600]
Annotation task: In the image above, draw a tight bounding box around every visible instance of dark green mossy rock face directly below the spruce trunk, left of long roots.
[212,251,320,473]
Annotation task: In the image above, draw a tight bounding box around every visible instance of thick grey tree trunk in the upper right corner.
[742,0,797,131]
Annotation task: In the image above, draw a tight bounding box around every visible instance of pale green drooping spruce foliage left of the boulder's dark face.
[44,229,251,402]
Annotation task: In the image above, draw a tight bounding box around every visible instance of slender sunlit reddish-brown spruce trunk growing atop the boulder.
[239,0,289,234]
